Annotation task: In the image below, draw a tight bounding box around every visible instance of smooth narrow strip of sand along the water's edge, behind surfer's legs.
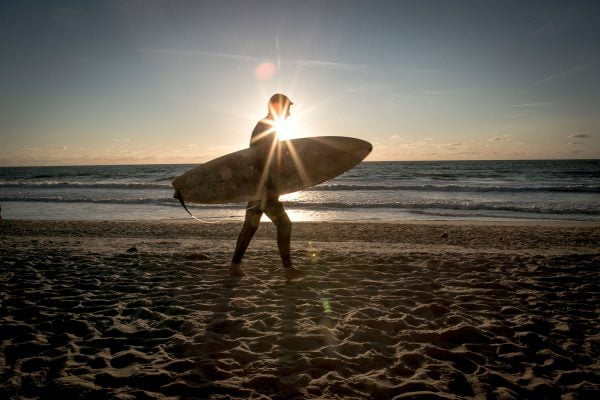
[0,219,600,244]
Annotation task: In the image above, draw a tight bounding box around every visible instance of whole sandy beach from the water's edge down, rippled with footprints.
[0,221,600,399]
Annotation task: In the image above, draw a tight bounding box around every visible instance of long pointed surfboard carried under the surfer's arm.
[172,136,373,204]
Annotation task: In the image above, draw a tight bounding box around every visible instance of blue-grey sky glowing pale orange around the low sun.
[0,0,600,166]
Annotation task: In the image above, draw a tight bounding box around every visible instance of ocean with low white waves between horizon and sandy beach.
[0,160,600,222]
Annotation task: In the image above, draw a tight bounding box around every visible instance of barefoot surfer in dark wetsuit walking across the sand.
[229,94,304,279]
